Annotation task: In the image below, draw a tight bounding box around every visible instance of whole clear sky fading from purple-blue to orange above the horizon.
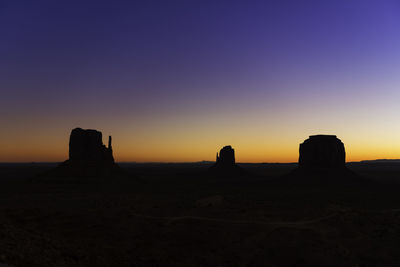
[0,0,400,162]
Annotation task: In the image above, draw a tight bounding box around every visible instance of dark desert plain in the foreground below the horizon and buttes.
[0,162,400,266]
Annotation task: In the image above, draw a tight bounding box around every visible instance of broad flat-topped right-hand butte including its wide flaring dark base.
[282,135,362,189]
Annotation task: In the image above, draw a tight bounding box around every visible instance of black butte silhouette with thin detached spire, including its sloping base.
[40,128,128,180]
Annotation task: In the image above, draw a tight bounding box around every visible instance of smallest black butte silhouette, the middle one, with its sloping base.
[209,146,243,176]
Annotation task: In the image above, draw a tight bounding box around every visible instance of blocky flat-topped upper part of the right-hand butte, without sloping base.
[299,135,346,169]
